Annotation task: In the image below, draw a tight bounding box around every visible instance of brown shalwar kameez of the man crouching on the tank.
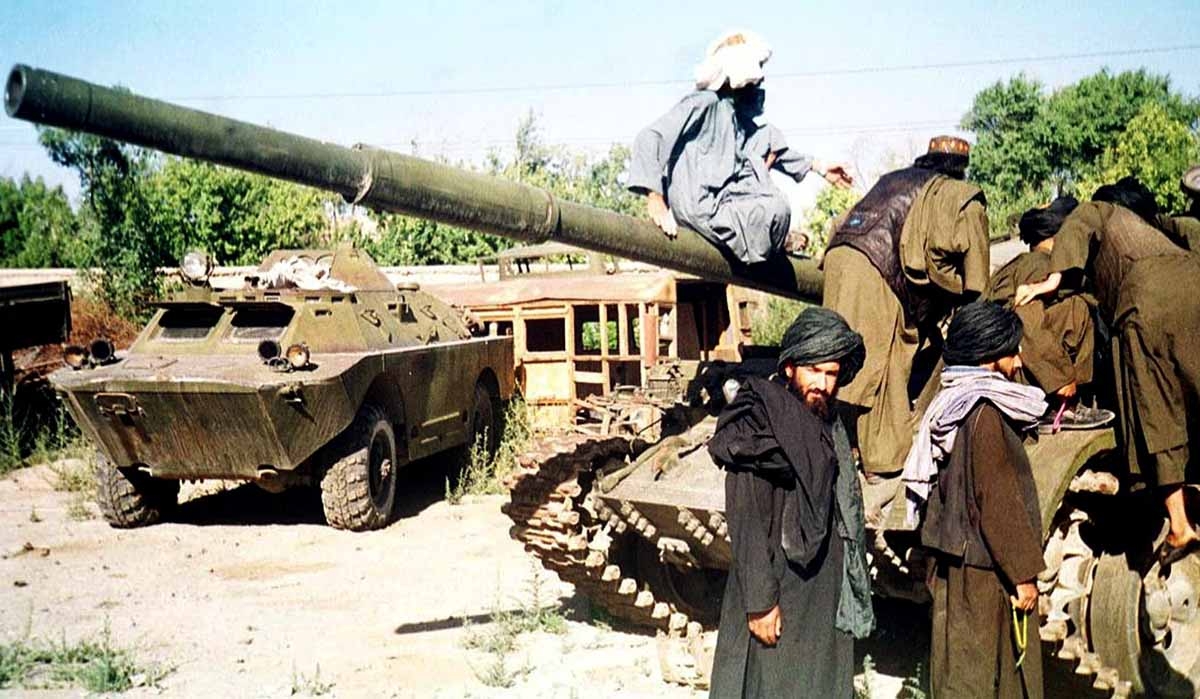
[986,250,1096,393]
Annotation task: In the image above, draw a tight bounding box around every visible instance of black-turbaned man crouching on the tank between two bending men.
[986,197,1112,429]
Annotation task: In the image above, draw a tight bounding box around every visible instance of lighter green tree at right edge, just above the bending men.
[1079,102,1200,211]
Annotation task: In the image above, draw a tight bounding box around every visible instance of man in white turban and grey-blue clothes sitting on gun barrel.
[629,31,851,264]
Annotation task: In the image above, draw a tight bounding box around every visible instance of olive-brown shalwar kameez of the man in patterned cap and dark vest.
[822,177,990,473]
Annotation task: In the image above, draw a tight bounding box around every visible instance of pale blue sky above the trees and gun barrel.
[0,0,1200,200]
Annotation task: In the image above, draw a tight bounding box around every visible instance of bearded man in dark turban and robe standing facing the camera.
[708,307,875,699]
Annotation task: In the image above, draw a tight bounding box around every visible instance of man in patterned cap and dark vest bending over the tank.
[823,136,989,502]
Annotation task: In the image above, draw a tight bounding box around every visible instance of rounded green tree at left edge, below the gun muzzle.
[0,175,86,267]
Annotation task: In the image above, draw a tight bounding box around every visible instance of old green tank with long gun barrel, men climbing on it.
[5,66,1200,697]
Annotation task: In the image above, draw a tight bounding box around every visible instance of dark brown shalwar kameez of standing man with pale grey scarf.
[922,402,1044,699]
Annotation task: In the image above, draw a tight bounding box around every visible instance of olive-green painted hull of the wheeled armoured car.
[52,250,512,479]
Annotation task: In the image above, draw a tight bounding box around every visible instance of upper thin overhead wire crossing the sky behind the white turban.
[166,43,1200,102]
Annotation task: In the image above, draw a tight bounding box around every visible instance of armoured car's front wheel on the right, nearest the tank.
[320,405,397,532]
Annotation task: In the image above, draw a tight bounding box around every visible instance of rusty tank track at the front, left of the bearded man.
[502,434,715,688]
